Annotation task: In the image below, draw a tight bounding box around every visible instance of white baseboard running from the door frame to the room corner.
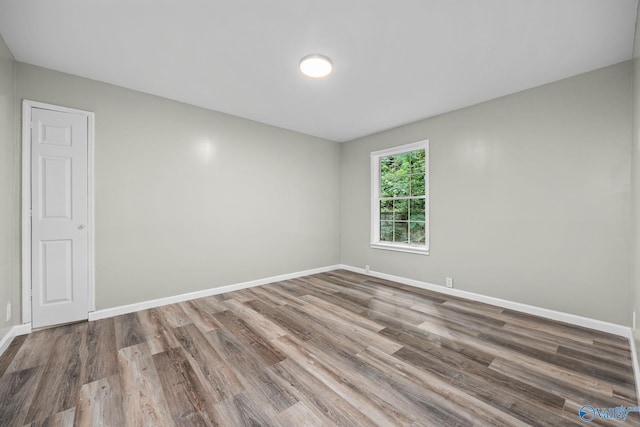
[89,265,341,321]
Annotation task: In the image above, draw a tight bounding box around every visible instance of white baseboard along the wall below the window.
[340,264,631,337]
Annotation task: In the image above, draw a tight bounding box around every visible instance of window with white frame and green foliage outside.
[371,140,429,255]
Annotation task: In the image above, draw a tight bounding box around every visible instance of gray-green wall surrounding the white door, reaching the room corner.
[17,63,340,309]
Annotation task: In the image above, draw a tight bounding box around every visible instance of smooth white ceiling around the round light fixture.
[0,0,638,141]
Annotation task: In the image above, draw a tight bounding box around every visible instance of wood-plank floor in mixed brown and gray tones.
[0,270,640,426]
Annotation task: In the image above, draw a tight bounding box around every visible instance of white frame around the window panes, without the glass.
[370,139,430,255]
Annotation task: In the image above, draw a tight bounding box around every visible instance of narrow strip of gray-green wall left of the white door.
[0,37,20,337]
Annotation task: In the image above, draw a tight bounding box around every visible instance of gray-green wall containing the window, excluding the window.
[340,62,632,325]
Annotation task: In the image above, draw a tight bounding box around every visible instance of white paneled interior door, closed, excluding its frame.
[31,108,89,328]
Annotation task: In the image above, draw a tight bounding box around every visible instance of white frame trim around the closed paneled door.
[21,99,96,324]
